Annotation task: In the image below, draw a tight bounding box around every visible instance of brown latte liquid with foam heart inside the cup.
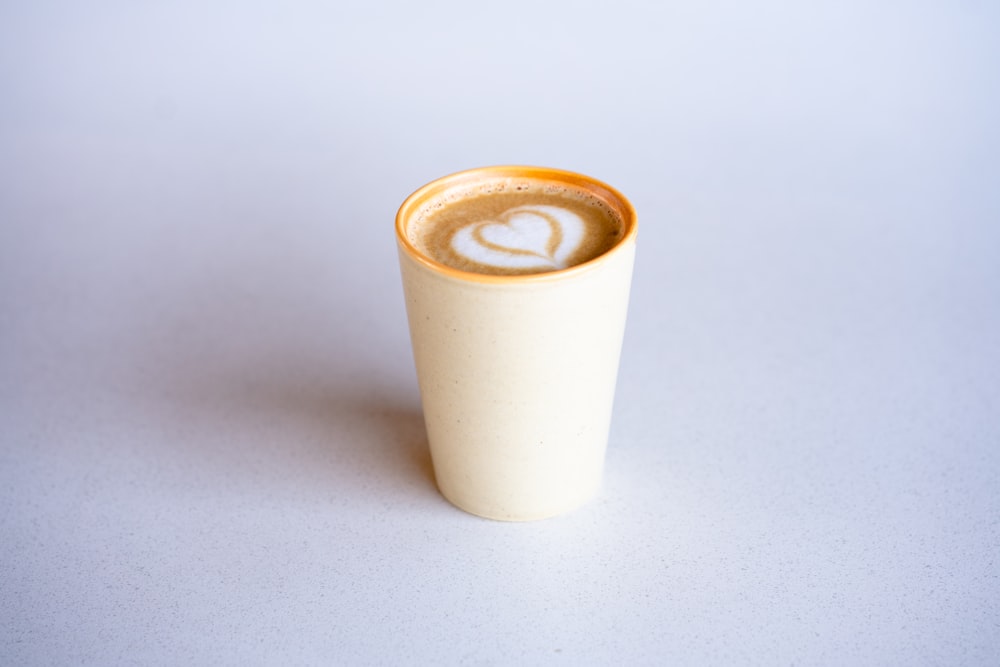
[407,176,624,275]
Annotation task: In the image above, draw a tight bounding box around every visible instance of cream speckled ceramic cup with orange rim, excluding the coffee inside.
[396,167,636,521]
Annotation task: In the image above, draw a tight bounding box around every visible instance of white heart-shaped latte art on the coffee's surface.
[451,205,584,270]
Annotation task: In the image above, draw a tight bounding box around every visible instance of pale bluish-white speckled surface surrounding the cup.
[0,1,1000,665]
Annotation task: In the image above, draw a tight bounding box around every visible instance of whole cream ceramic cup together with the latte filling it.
[396,166,637,521]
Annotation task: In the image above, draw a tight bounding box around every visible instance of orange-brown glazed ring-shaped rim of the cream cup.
[396,165,637,285]
